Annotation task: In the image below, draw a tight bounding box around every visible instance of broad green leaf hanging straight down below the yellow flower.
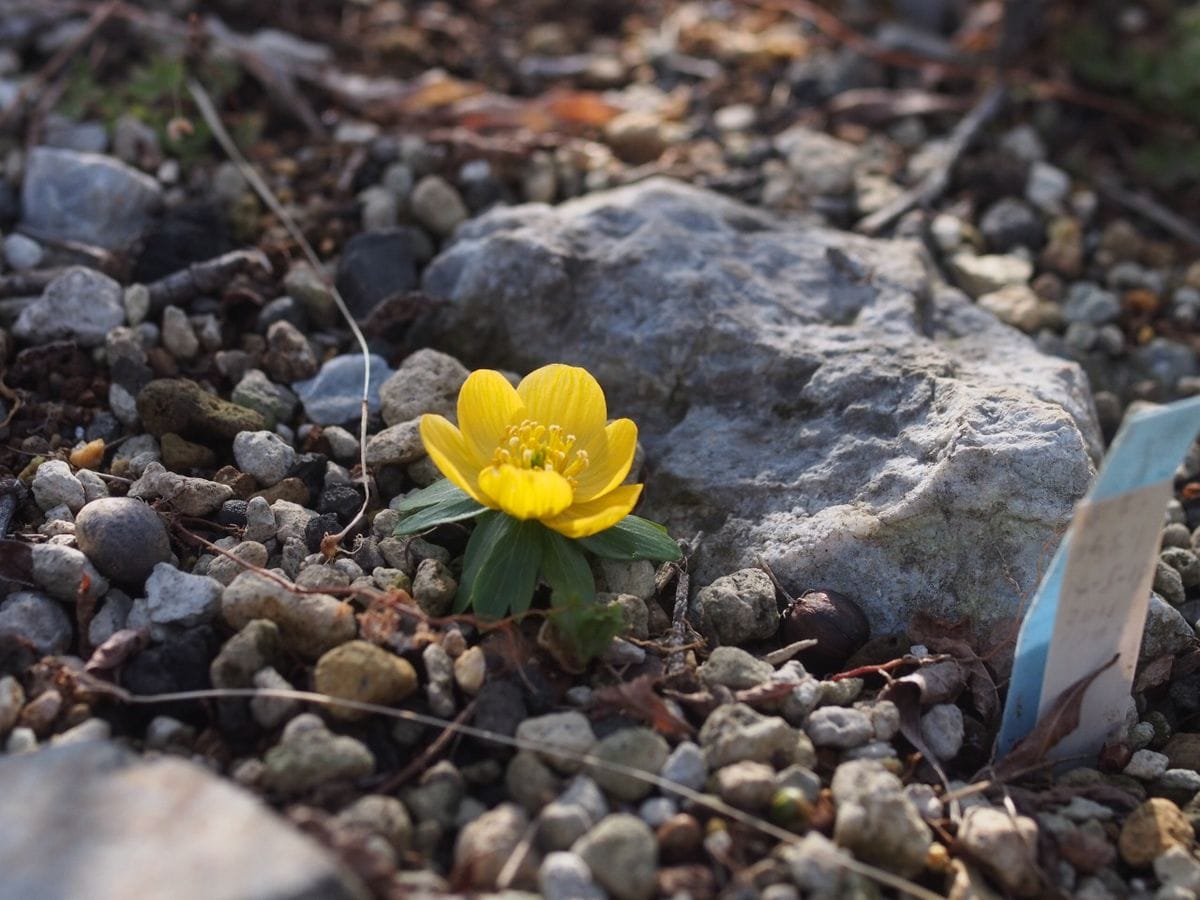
[455,512,542,619]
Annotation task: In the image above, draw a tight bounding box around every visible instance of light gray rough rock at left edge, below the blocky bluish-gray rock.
[12,265,125,347]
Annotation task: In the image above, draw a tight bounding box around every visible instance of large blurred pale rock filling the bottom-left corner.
[0,742,367,900]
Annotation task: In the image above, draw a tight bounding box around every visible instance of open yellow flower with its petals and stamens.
[421,364,642,538]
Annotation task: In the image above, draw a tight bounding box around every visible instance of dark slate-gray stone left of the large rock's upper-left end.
[337,228,426,321]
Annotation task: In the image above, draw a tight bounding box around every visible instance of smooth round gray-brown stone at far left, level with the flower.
[76,497,171,584]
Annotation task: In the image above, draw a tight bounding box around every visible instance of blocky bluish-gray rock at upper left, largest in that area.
[20,146,162,250]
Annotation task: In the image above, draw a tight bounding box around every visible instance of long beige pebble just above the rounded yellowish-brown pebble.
[221,571,358,659]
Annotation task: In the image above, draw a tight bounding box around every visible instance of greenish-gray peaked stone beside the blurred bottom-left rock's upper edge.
[263,713,376,797]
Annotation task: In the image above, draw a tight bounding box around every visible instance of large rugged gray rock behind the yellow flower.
[424,179,1100,632]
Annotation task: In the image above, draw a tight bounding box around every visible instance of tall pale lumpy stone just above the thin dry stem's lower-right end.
[830,760,934,877]
